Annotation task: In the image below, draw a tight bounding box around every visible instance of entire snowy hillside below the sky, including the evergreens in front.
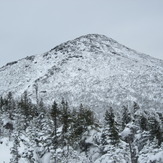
[0,34,163,163]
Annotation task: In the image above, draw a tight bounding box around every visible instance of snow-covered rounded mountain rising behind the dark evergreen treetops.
[0,34,163,112]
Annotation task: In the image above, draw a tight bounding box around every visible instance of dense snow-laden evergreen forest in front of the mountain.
[0,92,163,163]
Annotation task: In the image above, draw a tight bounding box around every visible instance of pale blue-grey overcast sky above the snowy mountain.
[0,0,163,67]
